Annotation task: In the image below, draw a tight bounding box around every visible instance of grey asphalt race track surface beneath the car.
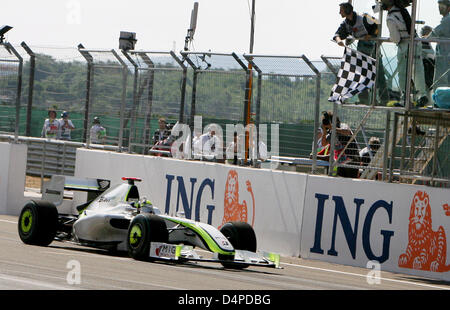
[0,216,450,291]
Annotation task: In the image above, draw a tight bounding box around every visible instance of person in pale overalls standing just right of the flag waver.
[381,0,430,106]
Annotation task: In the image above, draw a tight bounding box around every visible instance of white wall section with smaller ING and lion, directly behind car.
[75,149,307,256]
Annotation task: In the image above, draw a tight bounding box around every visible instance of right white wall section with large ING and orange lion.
[301,176,450,280]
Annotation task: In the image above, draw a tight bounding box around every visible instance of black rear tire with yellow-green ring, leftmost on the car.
[17,200,58,246]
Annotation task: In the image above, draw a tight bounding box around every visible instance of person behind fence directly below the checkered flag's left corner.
[321,111,360,178]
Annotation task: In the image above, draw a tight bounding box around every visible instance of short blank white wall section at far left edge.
[0,142,27,215]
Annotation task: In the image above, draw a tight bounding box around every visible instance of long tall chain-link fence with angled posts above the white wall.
[0,38,449,186]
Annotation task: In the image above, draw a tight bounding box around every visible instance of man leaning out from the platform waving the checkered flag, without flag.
[333,2,389,104]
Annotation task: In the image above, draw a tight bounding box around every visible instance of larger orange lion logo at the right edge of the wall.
[398,191,450,272]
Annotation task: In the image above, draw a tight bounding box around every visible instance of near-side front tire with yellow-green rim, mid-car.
[127,214,169,261]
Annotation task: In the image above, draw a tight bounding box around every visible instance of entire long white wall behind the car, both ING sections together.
[75,149,450,281]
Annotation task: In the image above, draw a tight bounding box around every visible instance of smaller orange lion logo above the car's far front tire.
[220,170,255,227]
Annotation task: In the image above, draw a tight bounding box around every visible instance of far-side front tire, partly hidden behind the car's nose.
[219,222,257,269]
